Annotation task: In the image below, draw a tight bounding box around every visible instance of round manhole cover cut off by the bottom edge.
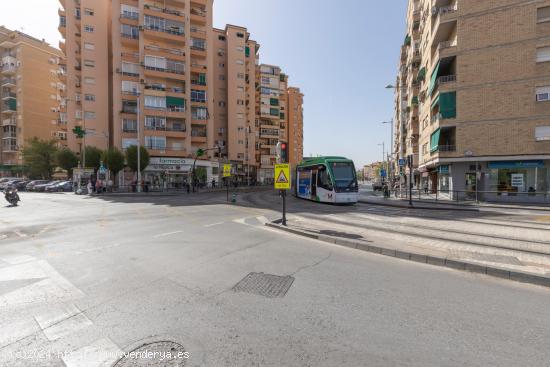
[113,341,189,367]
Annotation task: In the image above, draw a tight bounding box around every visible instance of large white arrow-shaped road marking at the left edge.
[0,260,84,309]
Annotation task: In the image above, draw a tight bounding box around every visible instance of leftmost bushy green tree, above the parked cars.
[22,137,57,180]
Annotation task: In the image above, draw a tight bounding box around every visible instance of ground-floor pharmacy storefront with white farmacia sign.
[142,157,219,190]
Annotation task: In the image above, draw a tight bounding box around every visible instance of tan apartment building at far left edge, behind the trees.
[0,26,67,175]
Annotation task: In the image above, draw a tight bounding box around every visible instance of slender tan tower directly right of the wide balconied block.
[212,25,260,182]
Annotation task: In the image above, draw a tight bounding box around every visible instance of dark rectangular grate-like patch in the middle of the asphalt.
[233,273,294,298]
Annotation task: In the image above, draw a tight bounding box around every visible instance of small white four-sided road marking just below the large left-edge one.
[34,304,92,341]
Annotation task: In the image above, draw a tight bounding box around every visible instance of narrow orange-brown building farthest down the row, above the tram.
[287,87,304,165]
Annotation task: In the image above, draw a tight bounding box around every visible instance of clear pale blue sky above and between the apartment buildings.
[0,0,407,166]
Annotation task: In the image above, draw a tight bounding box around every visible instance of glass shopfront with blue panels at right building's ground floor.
[489,161,550,193]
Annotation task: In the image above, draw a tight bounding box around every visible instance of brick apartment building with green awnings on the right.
[395,0,550,201]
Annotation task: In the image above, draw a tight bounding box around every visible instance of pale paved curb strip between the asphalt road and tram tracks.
[266,216,550,287]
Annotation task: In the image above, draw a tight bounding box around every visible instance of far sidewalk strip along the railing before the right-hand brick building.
[359,195,550,212]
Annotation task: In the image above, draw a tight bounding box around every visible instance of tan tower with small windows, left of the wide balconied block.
[59,0,111,154]
